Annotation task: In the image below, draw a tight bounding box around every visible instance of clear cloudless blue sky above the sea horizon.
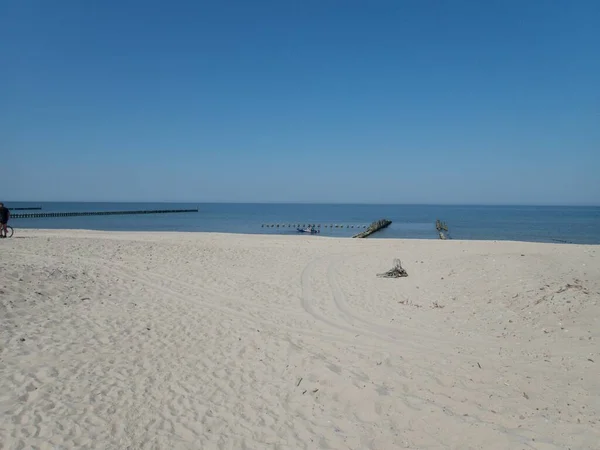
[0,0,600,205]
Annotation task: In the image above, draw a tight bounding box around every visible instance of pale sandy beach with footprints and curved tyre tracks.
[0,230,600,450]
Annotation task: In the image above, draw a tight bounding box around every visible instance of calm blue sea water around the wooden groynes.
[6,202,600,244]
